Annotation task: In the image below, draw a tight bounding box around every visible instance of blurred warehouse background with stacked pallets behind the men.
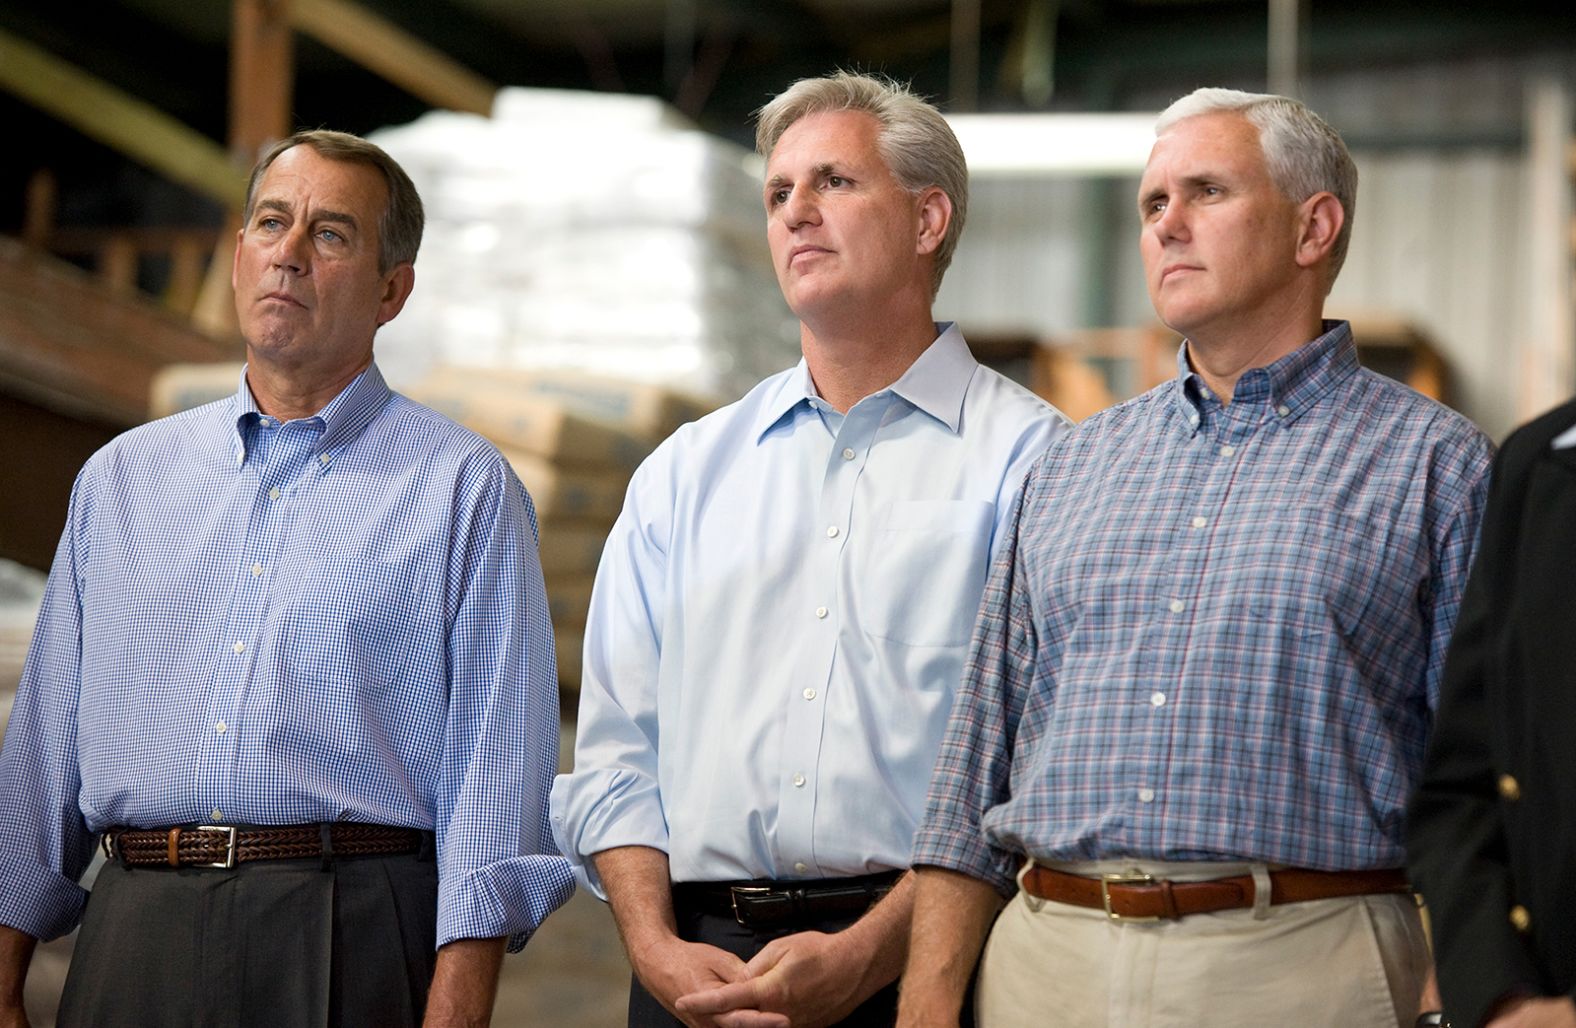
[0,0,1576,1025]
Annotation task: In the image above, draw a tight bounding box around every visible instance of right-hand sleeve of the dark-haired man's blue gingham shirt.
[437,457,574,951]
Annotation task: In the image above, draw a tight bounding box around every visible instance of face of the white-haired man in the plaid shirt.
[1138,112,1300,341]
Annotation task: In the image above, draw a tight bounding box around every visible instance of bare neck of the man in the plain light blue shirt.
[799,311,936,413]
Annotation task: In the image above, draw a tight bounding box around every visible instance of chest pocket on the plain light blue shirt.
[859,500,996,646]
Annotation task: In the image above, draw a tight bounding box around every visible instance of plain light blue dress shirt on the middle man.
[553,325,1065,892]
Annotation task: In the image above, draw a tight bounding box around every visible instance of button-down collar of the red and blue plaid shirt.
[1176,320,1359,432]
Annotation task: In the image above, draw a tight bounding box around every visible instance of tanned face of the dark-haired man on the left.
[230,145,413,382]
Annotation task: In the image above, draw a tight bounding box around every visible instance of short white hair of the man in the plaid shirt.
[1155,88,1357,284]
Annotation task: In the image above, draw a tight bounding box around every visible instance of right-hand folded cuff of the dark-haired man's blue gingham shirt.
[438,853,575,952]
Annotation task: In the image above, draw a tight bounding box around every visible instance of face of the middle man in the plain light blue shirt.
[766,110,932,318]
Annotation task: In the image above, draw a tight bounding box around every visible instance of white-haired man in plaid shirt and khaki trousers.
[901,90,1491,1028]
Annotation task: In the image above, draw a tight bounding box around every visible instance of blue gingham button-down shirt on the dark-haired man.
[0,366,572,946]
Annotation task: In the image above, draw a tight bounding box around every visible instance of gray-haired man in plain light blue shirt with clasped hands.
[553,74,1065,1025]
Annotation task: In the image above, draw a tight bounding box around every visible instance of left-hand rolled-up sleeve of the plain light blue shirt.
[552,440,673,897]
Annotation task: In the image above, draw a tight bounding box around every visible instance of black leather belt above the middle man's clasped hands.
[673,870,905,929]
